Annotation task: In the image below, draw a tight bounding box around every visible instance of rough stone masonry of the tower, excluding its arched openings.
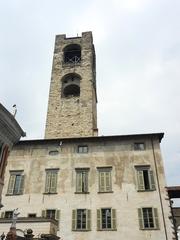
[45,32,97,138]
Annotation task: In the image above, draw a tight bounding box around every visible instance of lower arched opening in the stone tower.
[62,73,81,97]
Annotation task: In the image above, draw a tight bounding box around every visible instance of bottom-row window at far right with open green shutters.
[138,208,159,229]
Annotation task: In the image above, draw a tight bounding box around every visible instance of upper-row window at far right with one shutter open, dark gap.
[135,166,156,191]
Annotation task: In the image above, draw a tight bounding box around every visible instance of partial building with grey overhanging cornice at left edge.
[0,103,25,207]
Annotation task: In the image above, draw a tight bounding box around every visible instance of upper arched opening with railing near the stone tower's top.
[64,44,81,64]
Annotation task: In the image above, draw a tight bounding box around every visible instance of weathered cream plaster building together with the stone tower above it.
[0,32,173,240]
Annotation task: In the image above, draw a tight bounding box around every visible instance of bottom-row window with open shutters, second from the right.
[97,208,116,230]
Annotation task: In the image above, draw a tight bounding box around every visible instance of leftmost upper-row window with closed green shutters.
[7,171,24,195]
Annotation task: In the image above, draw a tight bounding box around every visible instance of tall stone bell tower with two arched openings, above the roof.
[45,32,97,139]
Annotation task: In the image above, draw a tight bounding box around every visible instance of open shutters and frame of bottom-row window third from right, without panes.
[72,208,91,232]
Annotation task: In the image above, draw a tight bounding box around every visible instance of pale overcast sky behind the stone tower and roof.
[0,0,180,189]
